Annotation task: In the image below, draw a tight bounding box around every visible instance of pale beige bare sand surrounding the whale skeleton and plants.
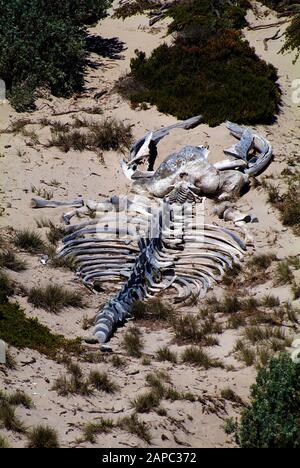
[0,2,300,447]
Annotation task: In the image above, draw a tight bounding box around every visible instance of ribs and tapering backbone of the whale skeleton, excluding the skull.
[58,200,246,343]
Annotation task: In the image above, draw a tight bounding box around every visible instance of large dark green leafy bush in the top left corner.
[0,0,111,112]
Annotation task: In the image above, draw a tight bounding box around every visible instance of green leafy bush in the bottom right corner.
[237,354,300,448]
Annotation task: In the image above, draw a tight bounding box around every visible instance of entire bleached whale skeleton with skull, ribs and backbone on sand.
[32,116,272,345]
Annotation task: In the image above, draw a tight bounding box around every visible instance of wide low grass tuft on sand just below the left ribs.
[28,284,84,313]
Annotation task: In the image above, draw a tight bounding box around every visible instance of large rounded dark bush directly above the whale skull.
[131,30,280,125]
